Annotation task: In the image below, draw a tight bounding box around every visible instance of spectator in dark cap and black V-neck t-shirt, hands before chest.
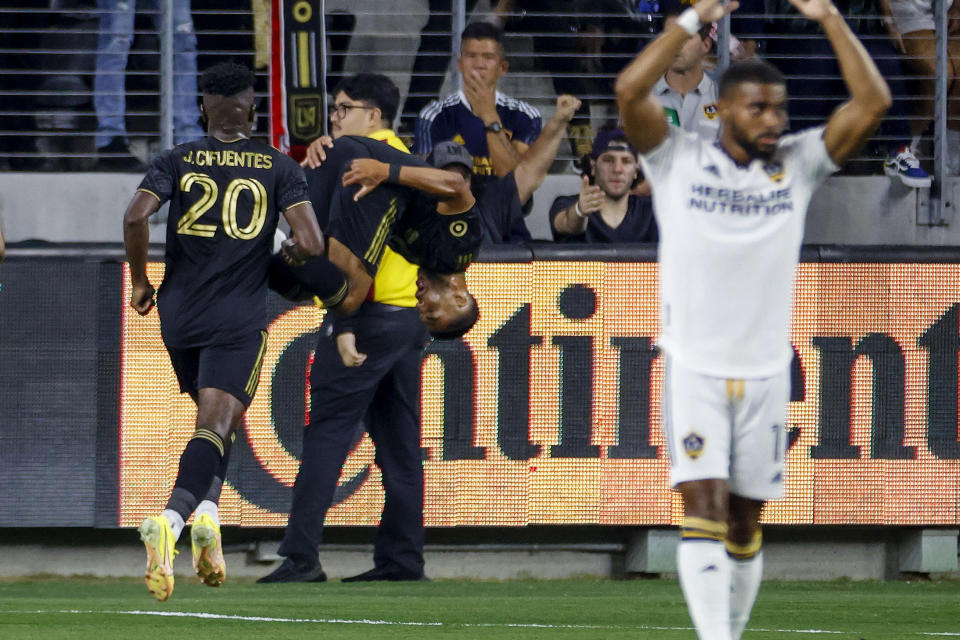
[550,129,657,243]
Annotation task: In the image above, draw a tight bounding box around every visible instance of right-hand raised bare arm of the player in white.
[790,0,890,165]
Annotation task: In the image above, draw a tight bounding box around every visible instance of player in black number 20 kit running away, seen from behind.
[124,62,324,601]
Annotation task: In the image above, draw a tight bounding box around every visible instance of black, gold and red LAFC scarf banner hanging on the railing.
[270,0,327,160]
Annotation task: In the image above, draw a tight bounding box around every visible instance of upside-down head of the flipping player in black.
[417,269,480,340]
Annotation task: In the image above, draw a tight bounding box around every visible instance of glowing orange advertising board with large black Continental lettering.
[119,262,960,526]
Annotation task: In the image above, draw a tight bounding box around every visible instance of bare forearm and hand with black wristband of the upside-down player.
[343,158,474,214]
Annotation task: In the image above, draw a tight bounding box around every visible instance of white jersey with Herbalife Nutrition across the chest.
[640,127,838,378]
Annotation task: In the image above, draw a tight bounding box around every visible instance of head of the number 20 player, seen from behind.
[199,61,256,140]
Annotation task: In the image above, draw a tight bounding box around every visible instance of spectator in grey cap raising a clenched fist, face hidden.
[428,95,580,244]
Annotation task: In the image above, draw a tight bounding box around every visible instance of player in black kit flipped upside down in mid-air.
[270,136,483,338]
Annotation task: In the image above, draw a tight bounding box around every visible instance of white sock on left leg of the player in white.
[677,540,732,640]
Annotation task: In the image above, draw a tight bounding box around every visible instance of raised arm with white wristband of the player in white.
[615,0,736,153]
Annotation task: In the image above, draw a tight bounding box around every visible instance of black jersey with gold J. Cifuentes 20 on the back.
[139,137,307,347]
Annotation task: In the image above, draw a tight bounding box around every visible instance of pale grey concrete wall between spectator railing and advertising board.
[0,173,960,246]
